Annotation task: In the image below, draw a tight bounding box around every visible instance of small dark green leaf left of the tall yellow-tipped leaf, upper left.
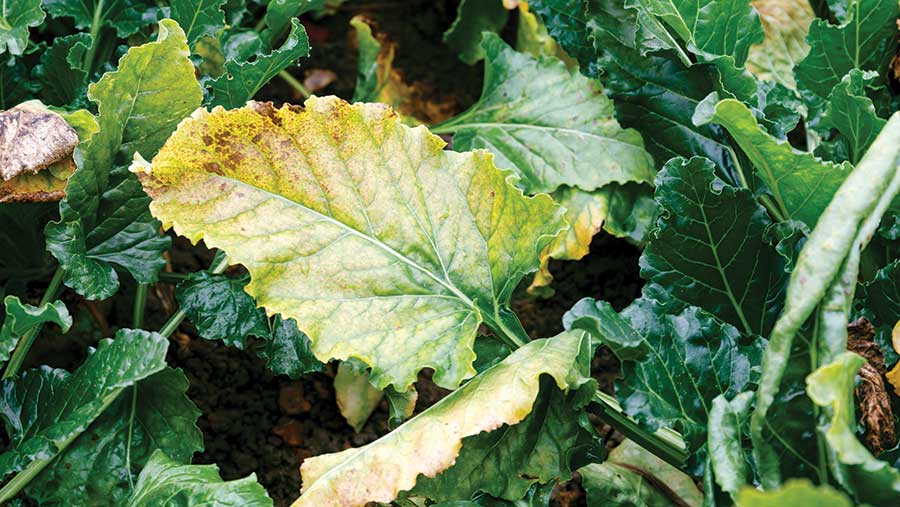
[33,33,92,106]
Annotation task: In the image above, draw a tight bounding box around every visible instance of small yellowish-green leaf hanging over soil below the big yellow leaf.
[334,359,384,433]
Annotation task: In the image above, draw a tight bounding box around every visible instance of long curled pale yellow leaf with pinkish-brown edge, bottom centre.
[293,332,594,507]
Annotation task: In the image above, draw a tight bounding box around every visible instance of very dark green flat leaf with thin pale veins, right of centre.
[640,157,787,335]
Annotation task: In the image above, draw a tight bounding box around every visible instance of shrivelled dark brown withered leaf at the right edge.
[847,318,897,456]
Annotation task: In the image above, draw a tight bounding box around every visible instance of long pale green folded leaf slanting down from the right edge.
[750,115,900,488]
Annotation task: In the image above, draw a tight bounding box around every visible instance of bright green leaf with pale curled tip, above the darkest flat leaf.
[694,95,852,229]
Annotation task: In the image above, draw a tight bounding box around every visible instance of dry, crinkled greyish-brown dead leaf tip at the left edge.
[0,103,78,181]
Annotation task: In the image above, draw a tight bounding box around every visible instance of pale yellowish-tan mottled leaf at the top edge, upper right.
[747,0,815,89]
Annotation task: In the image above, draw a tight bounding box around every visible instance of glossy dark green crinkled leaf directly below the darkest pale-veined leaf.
[576,298,764,473]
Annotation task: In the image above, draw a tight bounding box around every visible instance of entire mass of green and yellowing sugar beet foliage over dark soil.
[0,0,900,507]
